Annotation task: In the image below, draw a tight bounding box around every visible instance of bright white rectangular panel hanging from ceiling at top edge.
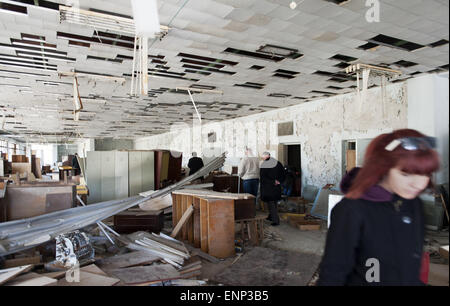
[131,0,161,38]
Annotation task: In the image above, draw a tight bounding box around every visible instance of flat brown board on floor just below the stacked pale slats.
[110,264,180,284]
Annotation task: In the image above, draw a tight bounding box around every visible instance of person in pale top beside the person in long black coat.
[239,148,259,201]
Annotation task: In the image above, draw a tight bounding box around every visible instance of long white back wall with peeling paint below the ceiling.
[135,83,408,191]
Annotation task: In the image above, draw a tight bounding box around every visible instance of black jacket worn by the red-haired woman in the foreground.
[318,191,424,286]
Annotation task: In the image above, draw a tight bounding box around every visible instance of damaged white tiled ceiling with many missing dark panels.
[0,0,449,142]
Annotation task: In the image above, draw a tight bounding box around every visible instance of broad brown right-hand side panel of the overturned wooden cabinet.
[208,199,235,258]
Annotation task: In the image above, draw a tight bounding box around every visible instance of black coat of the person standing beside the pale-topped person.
[259,157,286,202]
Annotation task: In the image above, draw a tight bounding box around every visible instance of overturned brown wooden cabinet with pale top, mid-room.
[172,189,254,258]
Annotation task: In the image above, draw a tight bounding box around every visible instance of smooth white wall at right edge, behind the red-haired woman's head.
[407,72,449,184]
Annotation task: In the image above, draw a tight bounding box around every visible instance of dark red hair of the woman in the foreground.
[345,129,439,199]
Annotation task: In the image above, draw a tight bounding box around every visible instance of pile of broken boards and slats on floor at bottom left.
[0,232,207,286]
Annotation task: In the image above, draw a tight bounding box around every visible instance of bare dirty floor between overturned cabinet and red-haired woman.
[199,211,327,286]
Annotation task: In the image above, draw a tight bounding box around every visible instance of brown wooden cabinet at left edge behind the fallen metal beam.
[0,182,76,222]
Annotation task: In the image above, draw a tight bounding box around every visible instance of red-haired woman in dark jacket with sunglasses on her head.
[318,129,439,286]
